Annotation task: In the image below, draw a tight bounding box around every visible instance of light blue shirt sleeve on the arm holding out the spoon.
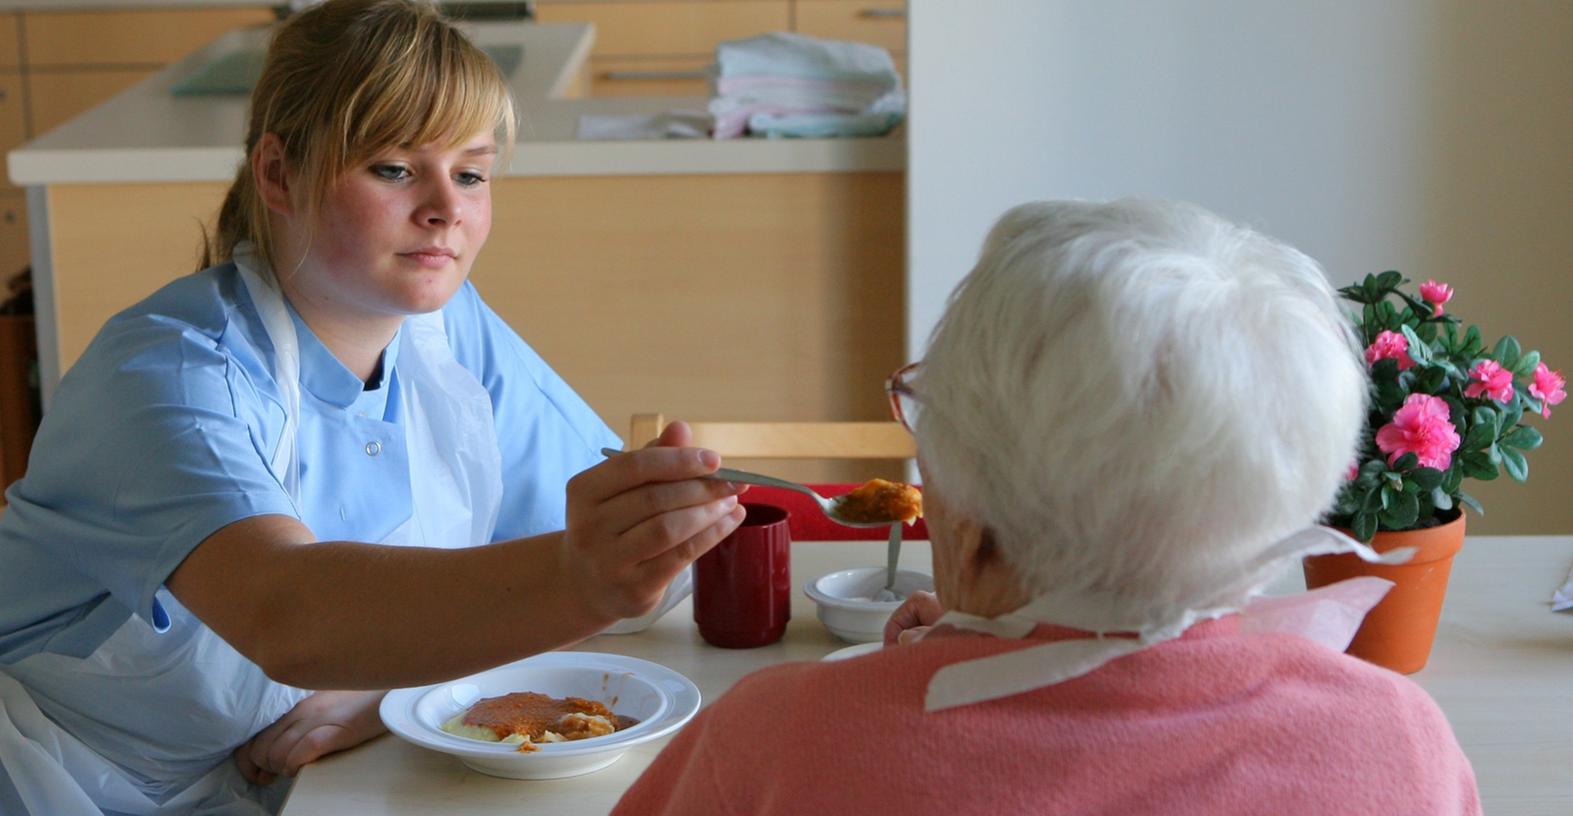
[0,277,299,662]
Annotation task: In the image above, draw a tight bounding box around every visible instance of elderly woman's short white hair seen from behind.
[914,200,1367,619]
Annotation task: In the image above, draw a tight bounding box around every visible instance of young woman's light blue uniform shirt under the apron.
[0,264,621,665]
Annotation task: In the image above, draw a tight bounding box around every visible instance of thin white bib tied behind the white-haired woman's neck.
[923,527,1414,711]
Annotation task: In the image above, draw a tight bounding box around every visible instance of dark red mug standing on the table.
[694,502,791,649]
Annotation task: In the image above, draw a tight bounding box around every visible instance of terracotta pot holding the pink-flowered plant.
[1302,513,1464,674]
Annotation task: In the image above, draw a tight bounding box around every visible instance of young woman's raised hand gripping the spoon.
[560,423,744,624]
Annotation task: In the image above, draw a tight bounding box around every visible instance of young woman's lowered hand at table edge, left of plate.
[234,692,387,785]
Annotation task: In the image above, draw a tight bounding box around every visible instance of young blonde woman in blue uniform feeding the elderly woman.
[0,0,742,814]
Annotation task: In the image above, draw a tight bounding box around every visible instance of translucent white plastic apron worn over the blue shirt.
[0,247,502,816]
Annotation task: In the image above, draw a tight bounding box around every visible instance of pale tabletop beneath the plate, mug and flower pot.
[283,536,1573,816]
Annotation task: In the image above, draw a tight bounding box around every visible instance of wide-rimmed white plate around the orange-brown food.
[379,651,700,780]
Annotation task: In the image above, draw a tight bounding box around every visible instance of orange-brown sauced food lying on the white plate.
[442,692,639,752]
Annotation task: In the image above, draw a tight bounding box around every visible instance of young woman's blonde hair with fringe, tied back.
[201,0,516,275]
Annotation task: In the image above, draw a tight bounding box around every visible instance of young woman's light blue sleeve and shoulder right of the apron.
[444,281,623,541]
